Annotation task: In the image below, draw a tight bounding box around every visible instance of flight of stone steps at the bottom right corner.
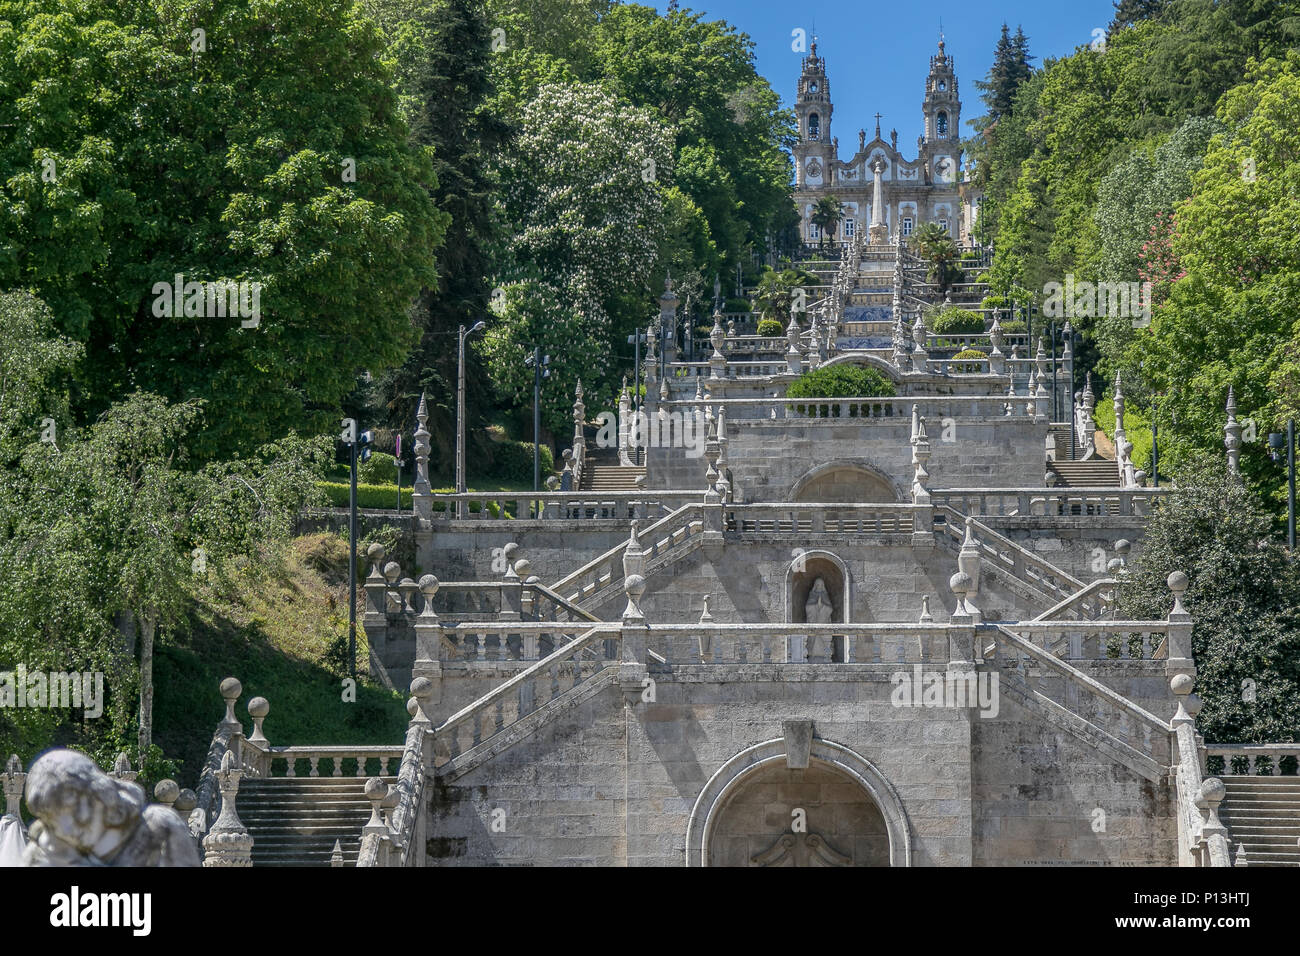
[1219,775,1300,866]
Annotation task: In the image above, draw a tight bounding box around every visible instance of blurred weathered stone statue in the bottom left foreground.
[23,749,199,866]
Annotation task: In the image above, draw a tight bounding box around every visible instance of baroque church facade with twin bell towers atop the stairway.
[793,39,979,245]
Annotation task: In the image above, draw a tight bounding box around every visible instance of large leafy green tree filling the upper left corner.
[0,0,445,458]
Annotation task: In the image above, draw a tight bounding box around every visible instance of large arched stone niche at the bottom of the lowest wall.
[686,737,911,866]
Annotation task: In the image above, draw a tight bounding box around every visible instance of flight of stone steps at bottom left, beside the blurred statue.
[237,777,397,866]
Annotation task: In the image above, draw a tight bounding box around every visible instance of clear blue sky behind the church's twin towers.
[649,0,1114,156]
